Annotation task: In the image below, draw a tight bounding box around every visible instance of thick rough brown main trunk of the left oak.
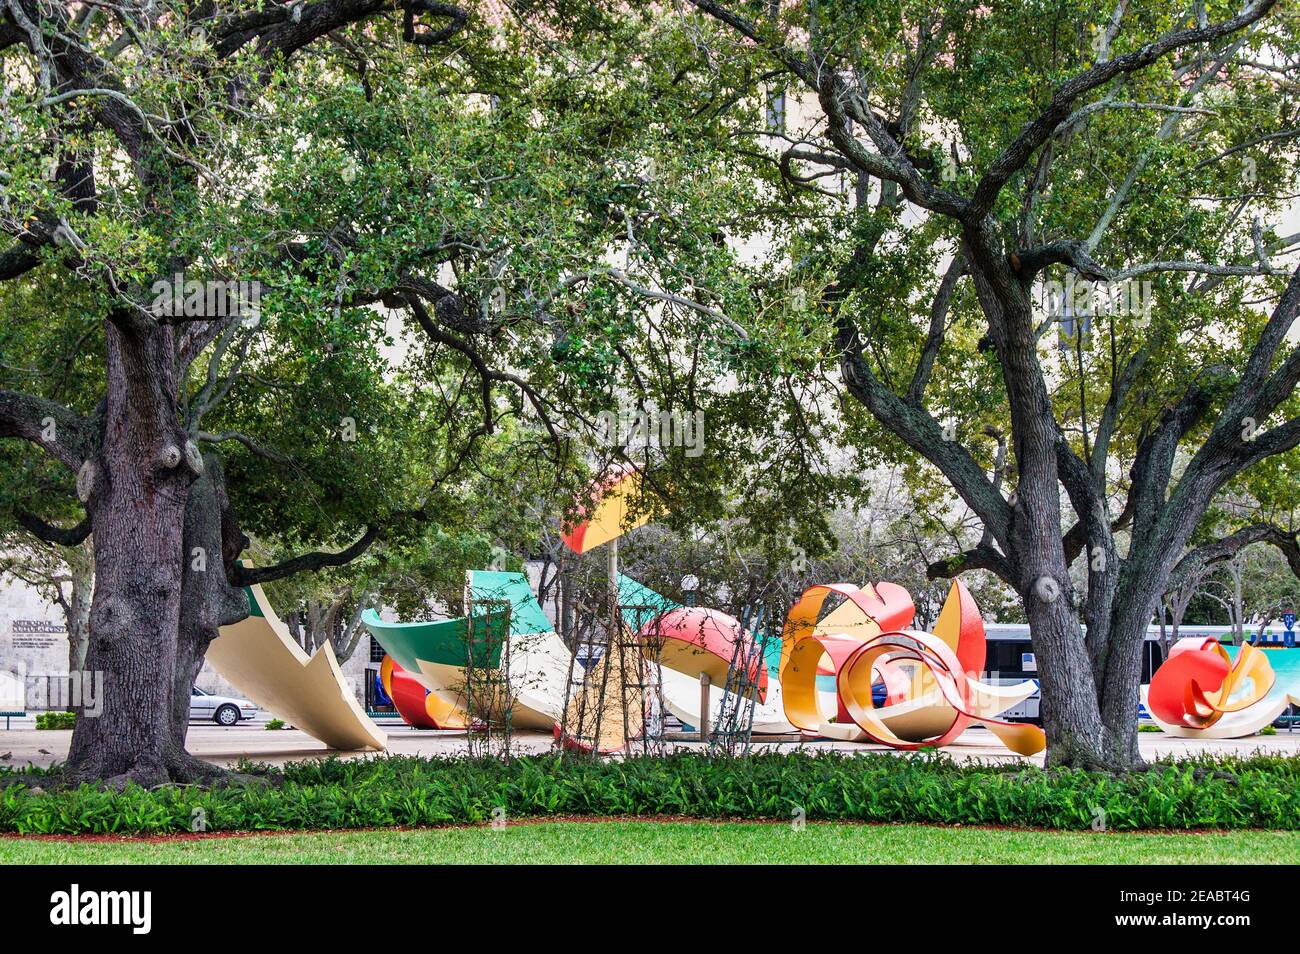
[66,316,200,785]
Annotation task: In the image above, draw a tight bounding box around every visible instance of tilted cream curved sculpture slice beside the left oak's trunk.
[207,586,387,750]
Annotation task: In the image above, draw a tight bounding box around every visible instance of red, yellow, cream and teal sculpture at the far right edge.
[1141,637,1300,738]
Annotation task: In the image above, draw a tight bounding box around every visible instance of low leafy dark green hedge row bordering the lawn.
[0,753,1300,833]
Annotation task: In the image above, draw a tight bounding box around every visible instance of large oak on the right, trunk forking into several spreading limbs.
[693,0,1300,768]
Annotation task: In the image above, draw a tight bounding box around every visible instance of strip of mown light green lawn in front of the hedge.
[0,821,1300,864]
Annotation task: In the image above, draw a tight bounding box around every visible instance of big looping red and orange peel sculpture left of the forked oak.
[781,581,1047,755]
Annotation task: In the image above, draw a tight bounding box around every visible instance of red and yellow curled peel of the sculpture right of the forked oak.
[1147,637,1275,729]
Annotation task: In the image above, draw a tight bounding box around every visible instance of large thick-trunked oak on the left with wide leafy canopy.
[0,0,821,785]
